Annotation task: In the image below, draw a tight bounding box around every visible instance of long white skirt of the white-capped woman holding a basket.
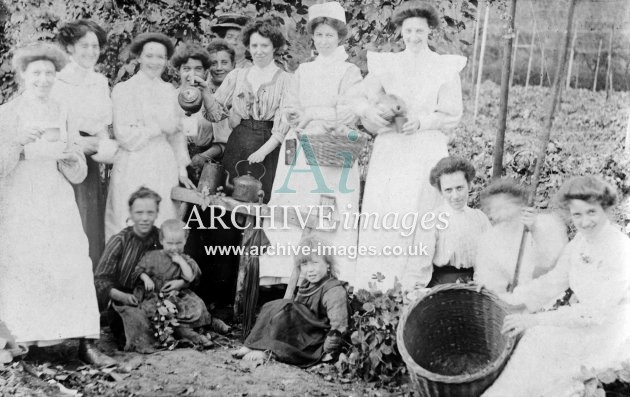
[260,132,360,285]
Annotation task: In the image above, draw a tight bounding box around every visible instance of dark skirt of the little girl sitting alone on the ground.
[245,299,330,367]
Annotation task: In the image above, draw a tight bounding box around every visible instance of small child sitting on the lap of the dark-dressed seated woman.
[133,219,212,347]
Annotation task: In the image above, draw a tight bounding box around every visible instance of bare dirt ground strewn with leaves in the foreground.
[0,328,409,397]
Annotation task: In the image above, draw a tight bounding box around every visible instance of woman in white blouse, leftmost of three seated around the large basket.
[403,156,490,287]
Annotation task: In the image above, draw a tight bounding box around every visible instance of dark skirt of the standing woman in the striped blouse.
[223,119,280,203]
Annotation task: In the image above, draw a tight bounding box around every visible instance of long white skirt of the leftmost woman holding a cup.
[0,161,99,344]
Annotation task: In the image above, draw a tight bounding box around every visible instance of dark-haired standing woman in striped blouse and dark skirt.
[203,19,291,203]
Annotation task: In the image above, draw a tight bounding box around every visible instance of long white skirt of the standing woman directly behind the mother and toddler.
[105,135,179,240]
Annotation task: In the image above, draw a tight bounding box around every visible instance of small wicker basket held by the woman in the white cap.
[297,130,368,168]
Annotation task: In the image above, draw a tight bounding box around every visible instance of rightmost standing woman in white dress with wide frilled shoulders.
[356,1,466,290]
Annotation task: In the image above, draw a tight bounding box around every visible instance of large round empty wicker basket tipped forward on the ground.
[396,284,516,397]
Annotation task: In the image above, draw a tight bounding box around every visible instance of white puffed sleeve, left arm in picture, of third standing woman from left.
[112,80,162,151]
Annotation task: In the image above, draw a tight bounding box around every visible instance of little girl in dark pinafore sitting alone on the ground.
[234,236,348,367]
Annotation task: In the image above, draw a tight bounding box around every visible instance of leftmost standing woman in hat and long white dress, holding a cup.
[0,43,115,365]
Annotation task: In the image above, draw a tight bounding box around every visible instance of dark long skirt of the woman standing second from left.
[74,156,108,268]
